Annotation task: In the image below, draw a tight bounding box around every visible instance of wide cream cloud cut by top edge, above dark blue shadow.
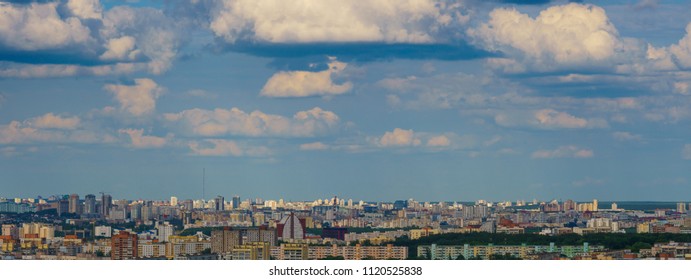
[210,0,460,43]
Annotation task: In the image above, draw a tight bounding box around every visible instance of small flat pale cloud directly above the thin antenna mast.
[188,139,271,157]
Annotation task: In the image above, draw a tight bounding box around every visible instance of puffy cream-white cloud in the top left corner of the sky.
[0,3,91,51]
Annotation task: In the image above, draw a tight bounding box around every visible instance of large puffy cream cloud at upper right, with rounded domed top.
[469,3,622,70]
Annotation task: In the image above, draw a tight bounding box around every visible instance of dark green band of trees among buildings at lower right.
[393,232,691,255]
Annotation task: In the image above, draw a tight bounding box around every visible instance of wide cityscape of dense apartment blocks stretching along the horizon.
[0,193,691,260]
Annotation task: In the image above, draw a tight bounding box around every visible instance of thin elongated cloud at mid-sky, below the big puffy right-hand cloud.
[494,109,608,129]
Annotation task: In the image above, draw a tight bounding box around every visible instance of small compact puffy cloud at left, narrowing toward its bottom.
[104,79,163,117]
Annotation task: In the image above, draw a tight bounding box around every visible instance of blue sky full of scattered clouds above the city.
[0,0,691,201]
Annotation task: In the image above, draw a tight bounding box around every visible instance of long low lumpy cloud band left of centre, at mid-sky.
[164,107,340,137]
